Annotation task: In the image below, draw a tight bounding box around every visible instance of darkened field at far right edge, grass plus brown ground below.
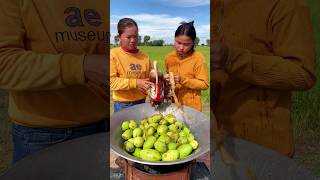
[292,0,320,177]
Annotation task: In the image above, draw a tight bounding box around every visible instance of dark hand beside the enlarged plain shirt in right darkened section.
[210,42,229,70]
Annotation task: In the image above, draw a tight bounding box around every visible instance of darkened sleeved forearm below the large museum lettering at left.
[0,47,84,91]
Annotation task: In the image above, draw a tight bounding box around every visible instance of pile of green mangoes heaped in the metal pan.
[121,114,199,161]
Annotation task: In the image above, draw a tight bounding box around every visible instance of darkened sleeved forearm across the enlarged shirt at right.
[225,48,315,90]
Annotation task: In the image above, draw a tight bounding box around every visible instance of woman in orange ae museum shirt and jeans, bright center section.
[110,18,151,112]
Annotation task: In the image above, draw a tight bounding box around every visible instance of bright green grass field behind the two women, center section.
[111,46,210,104]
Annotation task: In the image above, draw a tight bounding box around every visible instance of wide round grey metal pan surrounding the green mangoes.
[110,103,210,165]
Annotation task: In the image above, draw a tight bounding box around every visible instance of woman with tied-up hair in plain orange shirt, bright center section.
[165,21,209,111]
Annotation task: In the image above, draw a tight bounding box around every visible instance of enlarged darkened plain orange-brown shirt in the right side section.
[211,0,315,156]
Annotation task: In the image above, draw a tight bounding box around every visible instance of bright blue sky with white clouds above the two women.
[110,0,210,44]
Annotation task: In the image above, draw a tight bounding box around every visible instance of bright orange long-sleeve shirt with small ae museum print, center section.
[110,47,151,102]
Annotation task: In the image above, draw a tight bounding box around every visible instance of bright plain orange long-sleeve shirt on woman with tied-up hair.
[165,51,209,111]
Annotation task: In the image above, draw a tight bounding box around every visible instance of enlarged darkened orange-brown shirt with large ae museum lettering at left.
[0,0,109,127]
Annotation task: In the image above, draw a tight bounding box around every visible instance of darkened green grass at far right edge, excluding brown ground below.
[292,0,320,136]
